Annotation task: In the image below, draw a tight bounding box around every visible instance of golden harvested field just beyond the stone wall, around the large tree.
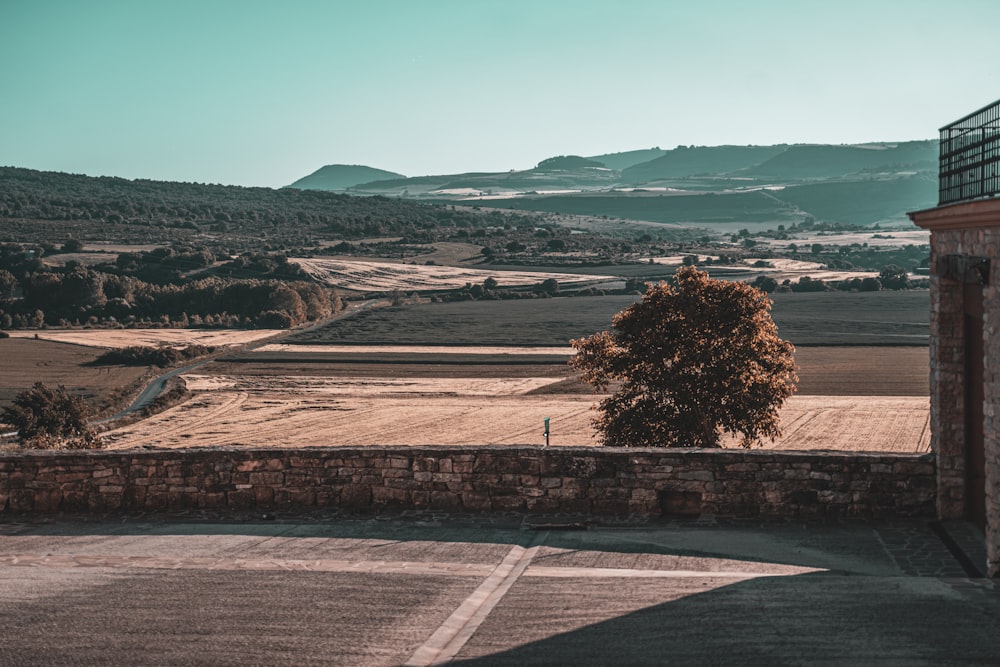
[106,348,929,451]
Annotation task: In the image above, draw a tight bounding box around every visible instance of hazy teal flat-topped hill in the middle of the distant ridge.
[622,144,788,185]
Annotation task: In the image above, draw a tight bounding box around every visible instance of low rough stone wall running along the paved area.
[0,447,936,517]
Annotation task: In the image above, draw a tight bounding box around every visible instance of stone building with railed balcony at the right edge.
[910,95,1000,577]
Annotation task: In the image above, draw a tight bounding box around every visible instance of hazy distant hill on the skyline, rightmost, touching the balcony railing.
[743,141,938,180]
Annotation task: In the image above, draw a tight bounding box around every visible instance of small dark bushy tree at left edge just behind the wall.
[2,382,100,449]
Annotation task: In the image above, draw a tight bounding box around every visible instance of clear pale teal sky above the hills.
[0,0,1000,187]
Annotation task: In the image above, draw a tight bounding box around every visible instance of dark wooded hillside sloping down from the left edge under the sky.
[0,167,534,254]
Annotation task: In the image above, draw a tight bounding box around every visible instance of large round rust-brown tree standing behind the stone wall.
[570,267,798,447]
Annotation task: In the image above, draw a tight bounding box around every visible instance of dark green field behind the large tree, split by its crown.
[286,290,930,346]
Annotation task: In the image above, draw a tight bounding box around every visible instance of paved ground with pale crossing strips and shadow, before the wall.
[0,514,1000,666]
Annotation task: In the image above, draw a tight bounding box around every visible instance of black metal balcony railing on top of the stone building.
[938,100,1000,206]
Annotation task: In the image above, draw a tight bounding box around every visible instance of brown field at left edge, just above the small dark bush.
[0,337,149,407]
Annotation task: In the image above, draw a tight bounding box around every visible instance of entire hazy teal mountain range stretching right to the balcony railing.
[288,140,938,227]
